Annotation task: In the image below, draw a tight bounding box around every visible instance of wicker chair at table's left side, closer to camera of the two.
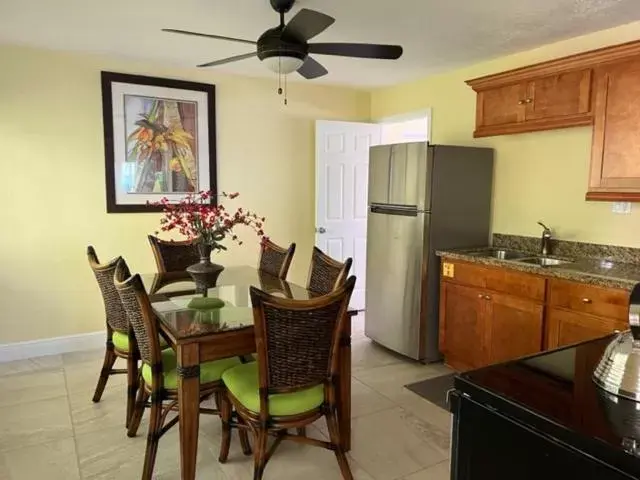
[114,259,251,480]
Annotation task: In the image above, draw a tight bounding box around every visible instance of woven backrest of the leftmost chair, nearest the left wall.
[87,245,129,333]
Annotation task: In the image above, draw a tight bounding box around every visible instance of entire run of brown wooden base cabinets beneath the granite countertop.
[439,259,629,370]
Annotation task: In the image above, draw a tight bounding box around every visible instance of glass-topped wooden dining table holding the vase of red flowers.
[141,266,357,480]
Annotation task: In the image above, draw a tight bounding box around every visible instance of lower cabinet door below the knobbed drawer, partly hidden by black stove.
[545,307,629,349]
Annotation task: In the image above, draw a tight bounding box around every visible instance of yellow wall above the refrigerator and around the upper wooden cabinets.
[371,22,640,247]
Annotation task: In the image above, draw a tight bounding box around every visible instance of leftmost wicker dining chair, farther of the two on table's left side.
[87,245,138,427]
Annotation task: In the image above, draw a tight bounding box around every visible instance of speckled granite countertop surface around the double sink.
[436,247,640,290]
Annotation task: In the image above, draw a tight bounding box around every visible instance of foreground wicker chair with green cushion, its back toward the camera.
[219,277,356,480]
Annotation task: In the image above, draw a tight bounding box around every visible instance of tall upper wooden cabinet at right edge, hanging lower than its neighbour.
[587,56,640,201]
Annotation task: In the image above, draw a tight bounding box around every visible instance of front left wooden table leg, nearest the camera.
[177,343,200,480]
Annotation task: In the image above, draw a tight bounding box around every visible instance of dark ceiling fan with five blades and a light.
[162,0,402,80]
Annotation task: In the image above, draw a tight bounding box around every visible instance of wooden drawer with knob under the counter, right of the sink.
[548,278,629,321]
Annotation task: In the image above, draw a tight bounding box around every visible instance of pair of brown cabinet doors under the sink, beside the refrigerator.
[440,282,543,370]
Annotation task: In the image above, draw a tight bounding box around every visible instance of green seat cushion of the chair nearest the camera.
[222,362,324,417]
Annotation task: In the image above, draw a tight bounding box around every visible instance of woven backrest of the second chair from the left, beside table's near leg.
[114,259,162,378]
